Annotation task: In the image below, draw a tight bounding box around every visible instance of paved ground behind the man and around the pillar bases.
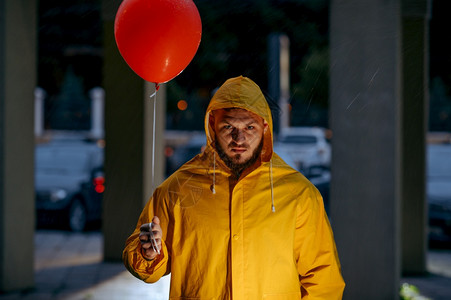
[0,230,451,300]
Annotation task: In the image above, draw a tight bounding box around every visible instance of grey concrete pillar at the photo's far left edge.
[0,0,37,291]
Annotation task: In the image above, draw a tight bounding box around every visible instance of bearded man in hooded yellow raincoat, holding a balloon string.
[123,76,344,300]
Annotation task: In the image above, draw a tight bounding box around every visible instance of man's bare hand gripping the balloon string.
[139,216,163,260]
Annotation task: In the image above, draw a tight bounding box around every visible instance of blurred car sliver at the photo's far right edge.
[427,144,451,242]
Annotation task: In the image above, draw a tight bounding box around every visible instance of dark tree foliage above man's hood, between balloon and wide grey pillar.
[168,0,328,129]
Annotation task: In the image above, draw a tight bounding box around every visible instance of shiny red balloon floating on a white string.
[114,0,202,83]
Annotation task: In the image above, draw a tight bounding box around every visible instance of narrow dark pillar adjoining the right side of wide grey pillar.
[401,0,429,274]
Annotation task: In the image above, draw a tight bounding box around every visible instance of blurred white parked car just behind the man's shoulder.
[275,127,331,177]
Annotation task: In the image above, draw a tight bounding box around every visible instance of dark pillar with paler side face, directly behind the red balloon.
[102,0,165,260]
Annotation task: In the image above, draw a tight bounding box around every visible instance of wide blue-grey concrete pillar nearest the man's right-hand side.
[330,0,402,300]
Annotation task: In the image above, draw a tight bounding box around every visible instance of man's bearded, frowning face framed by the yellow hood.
[213,108,268,172]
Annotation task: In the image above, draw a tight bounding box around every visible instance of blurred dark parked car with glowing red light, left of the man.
[35,141,105,232]
